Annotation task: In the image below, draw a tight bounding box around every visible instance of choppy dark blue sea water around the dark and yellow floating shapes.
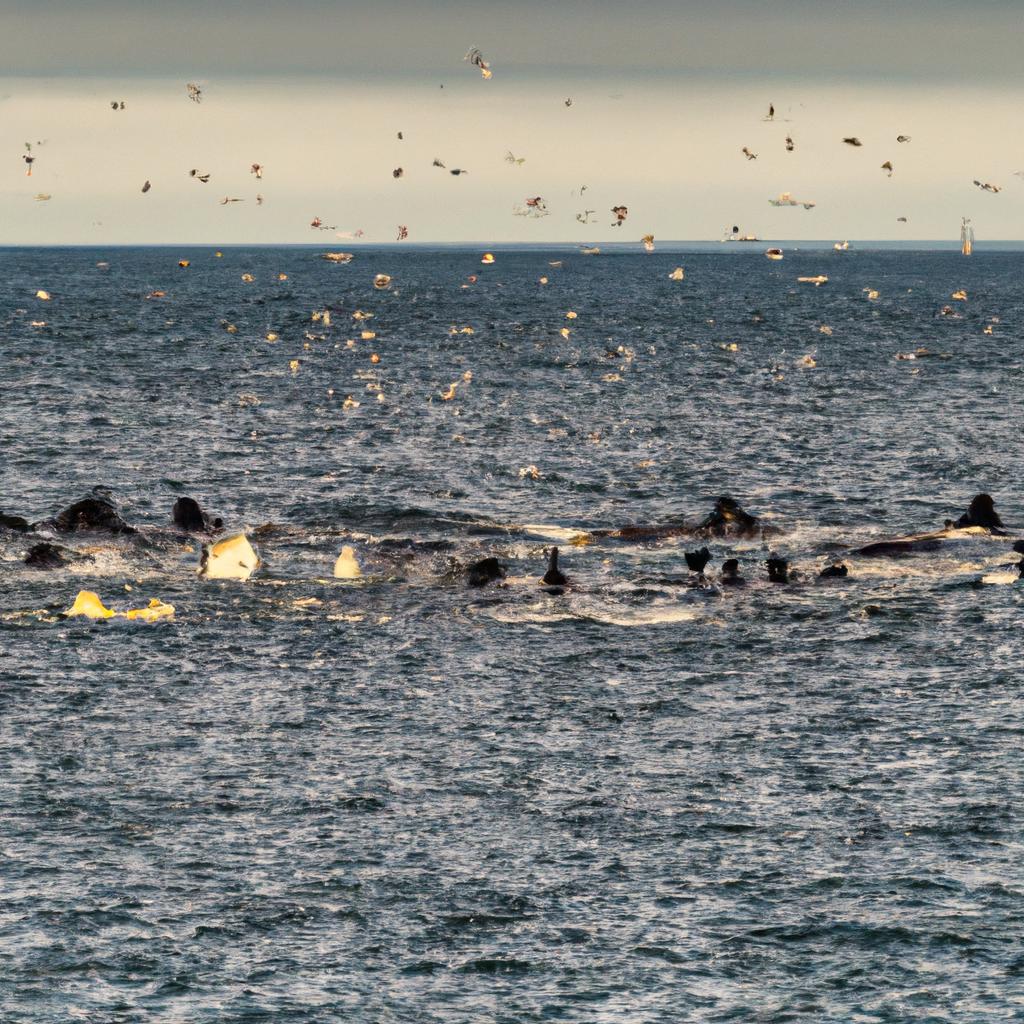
[0,247,1024,1024]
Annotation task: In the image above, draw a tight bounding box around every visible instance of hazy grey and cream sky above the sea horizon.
[0,0,1024,243]
